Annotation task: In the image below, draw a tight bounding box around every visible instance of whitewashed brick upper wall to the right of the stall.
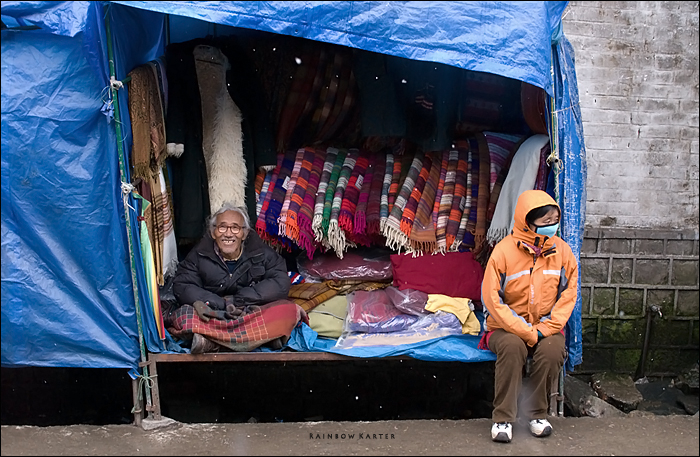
[564,1,700,228]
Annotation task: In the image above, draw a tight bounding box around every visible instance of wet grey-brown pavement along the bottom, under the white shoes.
[1,414,699,456]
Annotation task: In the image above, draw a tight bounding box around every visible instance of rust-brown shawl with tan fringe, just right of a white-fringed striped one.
[404,152,443,253]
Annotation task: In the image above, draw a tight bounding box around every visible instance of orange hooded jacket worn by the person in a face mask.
[481,190,578,346]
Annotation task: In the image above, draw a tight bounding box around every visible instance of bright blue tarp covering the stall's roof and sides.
[1,1,586,369]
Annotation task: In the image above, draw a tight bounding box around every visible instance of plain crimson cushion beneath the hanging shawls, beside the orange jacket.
[391,252,484,301]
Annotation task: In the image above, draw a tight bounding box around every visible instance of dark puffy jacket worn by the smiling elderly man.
[173,230,291,310]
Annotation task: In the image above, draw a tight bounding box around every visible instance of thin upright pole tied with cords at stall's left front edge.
[105,5,151,416]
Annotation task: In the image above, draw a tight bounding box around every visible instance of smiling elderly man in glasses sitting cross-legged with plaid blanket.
[166,204,308,354]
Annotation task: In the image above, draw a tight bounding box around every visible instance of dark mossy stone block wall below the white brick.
[575,229,700,375]
